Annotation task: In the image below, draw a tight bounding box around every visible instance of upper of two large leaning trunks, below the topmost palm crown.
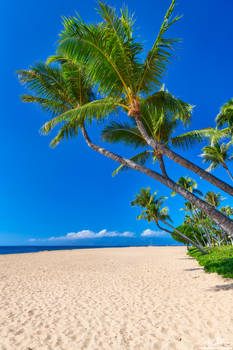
[134,114,233,196]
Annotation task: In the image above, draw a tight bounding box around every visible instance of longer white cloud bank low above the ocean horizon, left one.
[48,229,134,241]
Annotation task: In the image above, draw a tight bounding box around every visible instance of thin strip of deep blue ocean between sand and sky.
[0,244,181,255]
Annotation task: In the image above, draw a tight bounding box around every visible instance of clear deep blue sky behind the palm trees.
[0,0,233,245]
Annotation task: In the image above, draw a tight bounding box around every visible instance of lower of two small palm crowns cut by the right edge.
[201,141,233,181]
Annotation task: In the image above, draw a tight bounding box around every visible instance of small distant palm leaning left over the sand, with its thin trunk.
[131,188,207,254]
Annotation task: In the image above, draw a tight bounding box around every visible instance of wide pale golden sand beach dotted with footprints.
[0,247,233,350]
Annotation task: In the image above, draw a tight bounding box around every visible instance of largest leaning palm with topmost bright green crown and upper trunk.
[49,0,233,195]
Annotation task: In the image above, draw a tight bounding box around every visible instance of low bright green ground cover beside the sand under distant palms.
[188,246,233,278]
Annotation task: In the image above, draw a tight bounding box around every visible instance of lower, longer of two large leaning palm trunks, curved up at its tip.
[81,125,233,237]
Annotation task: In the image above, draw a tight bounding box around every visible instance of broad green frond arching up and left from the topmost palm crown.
[57,9,137,95]
